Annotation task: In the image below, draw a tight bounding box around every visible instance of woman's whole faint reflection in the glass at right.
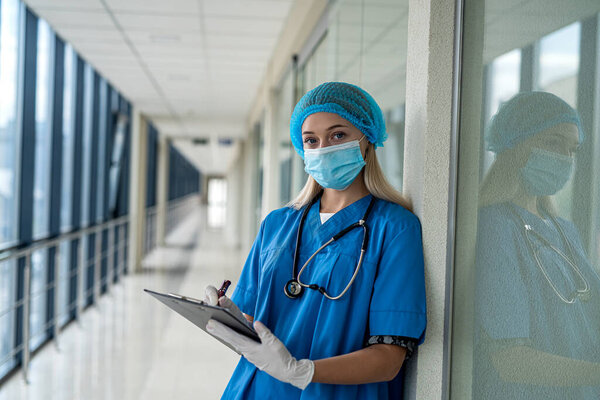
[473,92,600,400]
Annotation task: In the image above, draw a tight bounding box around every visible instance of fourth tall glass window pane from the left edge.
[81,64,94,226]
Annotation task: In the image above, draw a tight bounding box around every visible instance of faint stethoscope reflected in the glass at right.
[511,204,591,304]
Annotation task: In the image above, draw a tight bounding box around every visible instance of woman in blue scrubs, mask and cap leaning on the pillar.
[205,82,426,400]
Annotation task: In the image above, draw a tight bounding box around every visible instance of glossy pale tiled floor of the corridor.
[0,211,241,400]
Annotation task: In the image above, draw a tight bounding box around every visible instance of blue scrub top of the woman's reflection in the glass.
[473,203,600,400]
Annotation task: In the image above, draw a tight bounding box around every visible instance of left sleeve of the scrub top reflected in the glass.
[475,216,537,340]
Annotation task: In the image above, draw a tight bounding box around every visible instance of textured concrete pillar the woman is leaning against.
[403,0,456,399]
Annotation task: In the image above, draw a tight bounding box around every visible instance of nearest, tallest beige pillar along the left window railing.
[128,108,148,272]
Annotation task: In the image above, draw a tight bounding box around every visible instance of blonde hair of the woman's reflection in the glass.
[479,147,558,216]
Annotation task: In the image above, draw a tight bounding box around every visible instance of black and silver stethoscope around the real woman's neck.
[283,191,375,300]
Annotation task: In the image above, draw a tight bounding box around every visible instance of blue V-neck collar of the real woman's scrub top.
[303,194,373,244]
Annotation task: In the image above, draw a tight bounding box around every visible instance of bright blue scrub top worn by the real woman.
[222,195,426,400]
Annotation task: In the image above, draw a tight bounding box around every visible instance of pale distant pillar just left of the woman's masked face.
[261,90,281,219]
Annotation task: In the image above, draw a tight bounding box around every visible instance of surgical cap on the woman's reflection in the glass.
[487,92,584,153]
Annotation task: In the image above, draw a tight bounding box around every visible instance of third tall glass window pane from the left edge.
[60,44,77,231]
